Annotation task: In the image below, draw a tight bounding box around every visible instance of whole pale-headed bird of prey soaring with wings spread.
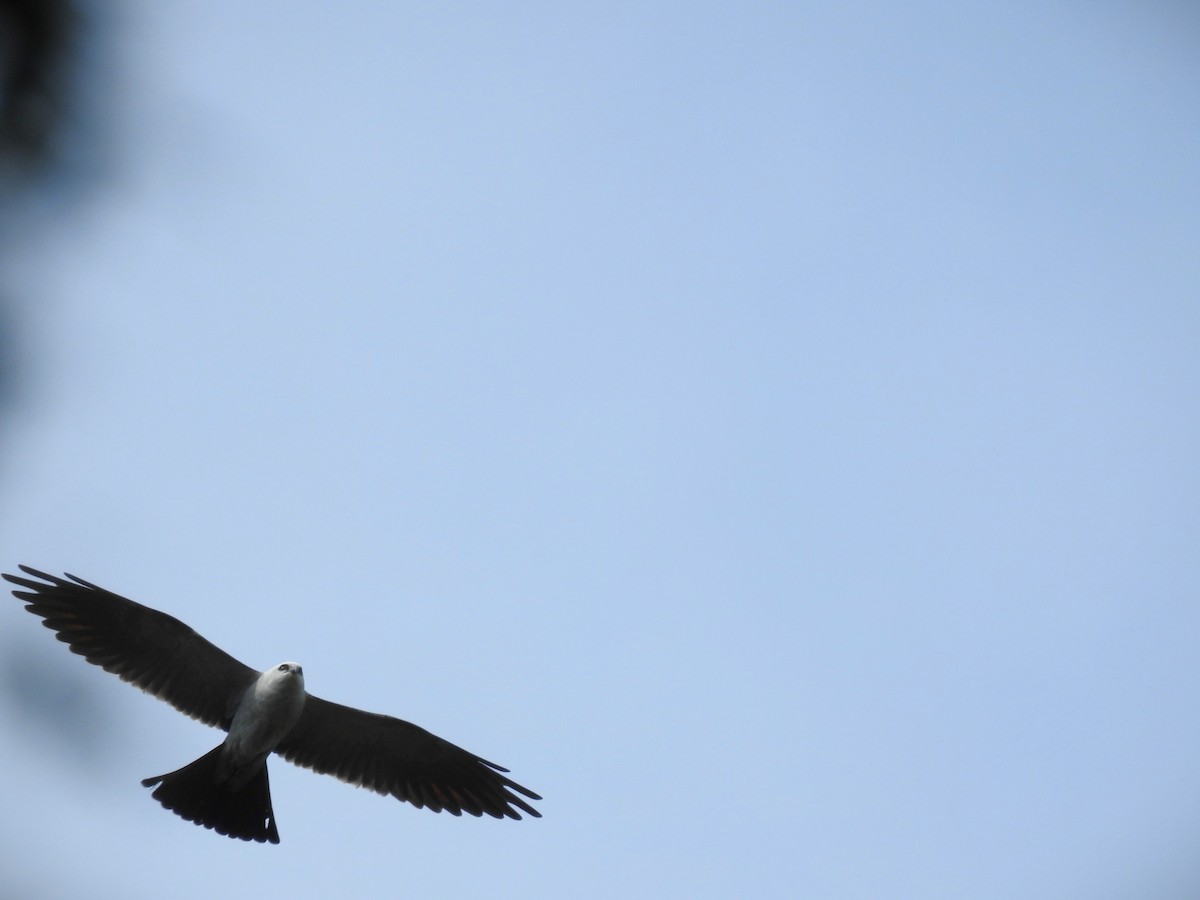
[4,565,541,844]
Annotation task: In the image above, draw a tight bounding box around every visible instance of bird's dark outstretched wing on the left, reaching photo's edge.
[4,565,258,731]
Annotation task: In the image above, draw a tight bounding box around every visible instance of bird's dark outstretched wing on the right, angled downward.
[275,694,541,818]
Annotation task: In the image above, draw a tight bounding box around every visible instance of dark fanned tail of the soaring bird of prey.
[142,746,280,844]
